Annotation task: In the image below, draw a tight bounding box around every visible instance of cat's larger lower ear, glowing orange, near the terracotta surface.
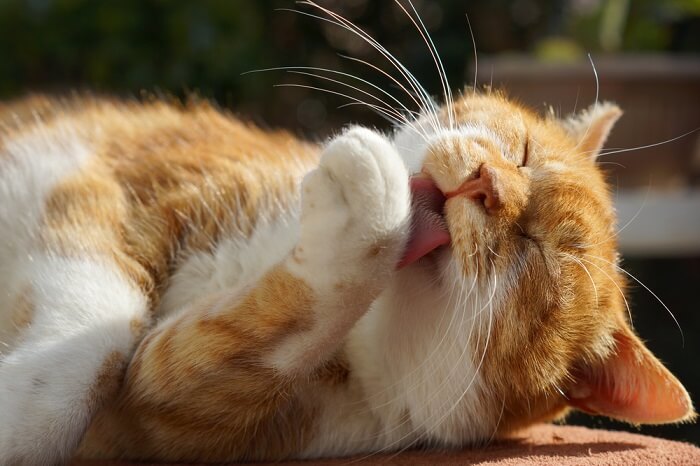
[567,328,695,424]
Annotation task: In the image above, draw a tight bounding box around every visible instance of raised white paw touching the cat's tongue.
[294,127,410,284]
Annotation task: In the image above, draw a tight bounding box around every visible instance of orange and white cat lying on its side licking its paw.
[0,85,694,465]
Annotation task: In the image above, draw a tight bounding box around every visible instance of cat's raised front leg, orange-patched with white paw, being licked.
[80,128,410,462]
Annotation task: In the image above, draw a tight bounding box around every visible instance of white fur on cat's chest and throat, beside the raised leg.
[305,268,500,457]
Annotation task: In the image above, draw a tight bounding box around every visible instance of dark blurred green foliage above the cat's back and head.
[0,0,700,134]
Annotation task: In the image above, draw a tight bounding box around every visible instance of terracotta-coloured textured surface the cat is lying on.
[73,425,700,466]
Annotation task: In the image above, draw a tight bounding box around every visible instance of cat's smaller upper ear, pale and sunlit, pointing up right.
[562,102,622,160]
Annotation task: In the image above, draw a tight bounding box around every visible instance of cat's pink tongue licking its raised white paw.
[397,177,450,269]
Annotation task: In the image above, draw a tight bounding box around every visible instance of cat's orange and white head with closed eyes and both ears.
[395,92,694,436]
